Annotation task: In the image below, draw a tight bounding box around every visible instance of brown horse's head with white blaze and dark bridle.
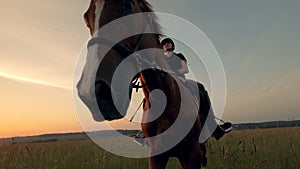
[77,0,160,121]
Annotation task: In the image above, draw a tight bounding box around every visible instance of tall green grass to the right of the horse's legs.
[207,127,300,169]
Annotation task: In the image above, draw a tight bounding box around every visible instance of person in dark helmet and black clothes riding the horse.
[161,38,232,140]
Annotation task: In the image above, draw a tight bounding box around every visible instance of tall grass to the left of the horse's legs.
[0,140,147,169]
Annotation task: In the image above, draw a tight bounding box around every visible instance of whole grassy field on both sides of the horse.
[0,127,300,169]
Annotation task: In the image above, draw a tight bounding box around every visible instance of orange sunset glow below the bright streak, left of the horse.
[0,77,81,137]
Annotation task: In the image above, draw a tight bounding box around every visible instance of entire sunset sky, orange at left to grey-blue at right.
[0,0,300,138]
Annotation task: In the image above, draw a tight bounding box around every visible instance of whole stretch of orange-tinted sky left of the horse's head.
[0,0,89,138]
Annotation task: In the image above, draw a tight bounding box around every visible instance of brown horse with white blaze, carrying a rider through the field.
[77,0,206,169]
